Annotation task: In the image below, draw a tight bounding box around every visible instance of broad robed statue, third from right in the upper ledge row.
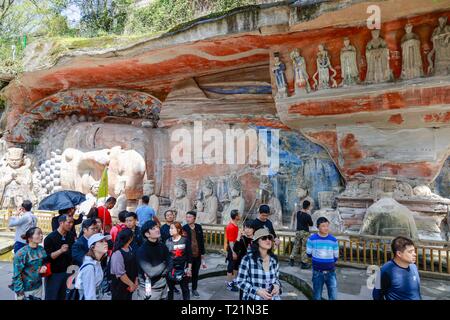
[366,29,393,83]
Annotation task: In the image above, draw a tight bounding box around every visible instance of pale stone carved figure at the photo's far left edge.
[0,148,34,209]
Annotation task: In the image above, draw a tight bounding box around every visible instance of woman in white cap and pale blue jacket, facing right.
[75,233,111,300]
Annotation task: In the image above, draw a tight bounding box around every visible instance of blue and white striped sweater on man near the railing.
[306,234,339,271]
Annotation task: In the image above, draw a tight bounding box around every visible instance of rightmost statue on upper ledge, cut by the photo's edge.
[428,17,450,75]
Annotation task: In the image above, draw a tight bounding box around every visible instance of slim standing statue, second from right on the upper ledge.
[400,23,423,80]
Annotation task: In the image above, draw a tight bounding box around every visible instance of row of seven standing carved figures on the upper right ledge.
[272,17,450,98]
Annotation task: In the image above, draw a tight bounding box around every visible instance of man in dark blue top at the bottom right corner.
[372,236,422,300]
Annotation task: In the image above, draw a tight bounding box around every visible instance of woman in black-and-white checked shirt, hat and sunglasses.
[236,228,281,300]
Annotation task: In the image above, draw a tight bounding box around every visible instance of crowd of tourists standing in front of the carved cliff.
[9,196,421,300]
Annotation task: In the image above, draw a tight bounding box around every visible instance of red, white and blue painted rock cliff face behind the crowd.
[2,0,450,237]
